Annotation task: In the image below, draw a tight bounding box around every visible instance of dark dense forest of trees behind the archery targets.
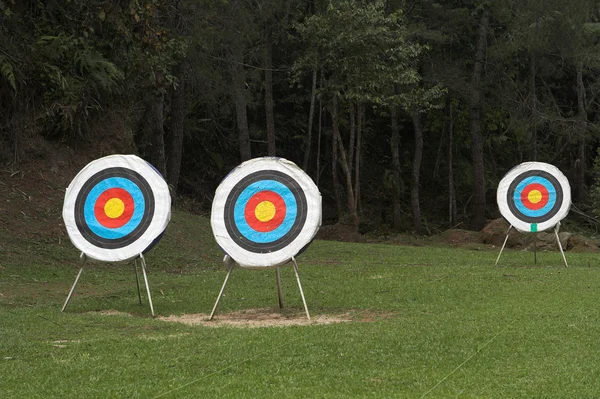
[0,0,600,234]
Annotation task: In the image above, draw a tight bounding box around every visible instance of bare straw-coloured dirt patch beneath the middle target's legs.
[158,308,390,328]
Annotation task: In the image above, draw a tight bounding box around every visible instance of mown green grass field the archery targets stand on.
[0,212,600,398]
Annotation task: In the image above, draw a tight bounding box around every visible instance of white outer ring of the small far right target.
[496,162,571,233]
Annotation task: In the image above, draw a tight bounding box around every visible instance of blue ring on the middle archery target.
[233,180,298,244]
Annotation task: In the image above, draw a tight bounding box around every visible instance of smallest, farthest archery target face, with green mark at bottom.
[496,162,571,232]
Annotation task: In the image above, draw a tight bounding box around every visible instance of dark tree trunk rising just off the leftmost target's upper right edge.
[167,61,186,194]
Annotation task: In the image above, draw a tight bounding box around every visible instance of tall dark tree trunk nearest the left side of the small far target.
[469,9,489,230]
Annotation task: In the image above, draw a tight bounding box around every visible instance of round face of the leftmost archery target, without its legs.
[63,155,171,262]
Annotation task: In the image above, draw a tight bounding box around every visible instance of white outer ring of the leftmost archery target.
[63,155,171,262]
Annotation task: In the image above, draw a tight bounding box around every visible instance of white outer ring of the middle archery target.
[210,157,321,269]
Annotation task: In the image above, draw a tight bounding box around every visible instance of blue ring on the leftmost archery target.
[83,177,146,240]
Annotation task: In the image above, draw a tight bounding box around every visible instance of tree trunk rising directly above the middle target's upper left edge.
[231,43,251,162]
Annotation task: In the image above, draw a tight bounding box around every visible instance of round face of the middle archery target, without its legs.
[211,157,321,268]
